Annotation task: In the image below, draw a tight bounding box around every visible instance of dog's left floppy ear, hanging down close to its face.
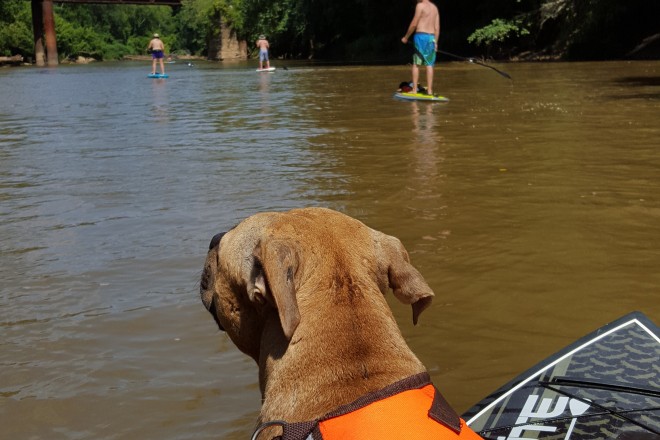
[248,240,300,340]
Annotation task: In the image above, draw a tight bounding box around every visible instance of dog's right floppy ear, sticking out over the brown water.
[379,234,434,325]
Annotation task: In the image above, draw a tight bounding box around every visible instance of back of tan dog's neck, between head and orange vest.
[262,304,425,421]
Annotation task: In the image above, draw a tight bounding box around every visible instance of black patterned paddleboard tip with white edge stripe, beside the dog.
[462,312,660,440]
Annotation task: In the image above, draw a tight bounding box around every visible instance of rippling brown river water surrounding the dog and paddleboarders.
[0,62,660,440]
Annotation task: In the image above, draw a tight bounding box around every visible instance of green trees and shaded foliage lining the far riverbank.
[0,0,660,61]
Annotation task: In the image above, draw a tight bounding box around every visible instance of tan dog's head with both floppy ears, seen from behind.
[200,208,433,361]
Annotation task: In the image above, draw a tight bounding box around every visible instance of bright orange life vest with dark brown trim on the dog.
[270,373,481,440]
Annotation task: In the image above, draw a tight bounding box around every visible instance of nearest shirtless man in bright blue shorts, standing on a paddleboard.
[401,0,440,95]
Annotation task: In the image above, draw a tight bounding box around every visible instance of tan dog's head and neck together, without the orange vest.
[200,208,482,439]
